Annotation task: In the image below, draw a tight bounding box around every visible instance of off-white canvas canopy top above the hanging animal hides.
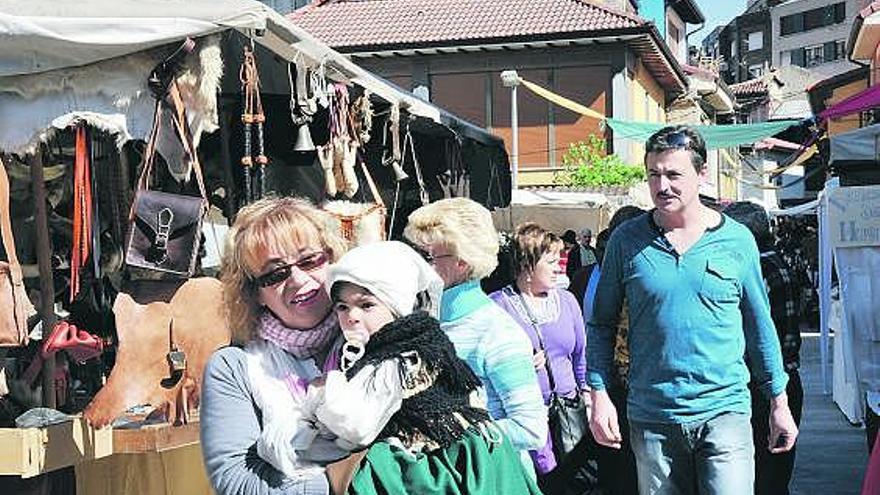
[0,0,262,77]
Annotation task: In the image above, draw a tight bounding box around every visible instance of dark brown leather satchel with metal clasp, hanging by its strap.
[125,81,208,278]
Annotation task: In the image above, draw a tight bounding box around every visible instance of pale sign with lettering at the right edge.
[828,186,880,247]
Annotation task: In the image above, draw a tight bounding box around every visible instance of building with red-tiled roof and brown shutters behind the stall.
[291,0,687,185]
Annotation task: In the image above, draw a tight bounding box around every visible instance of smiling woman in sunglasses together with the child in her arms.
[201,198,538,495]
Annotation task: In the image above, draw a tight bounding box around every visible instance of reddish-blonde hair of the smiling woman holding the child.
[220,197,347,344]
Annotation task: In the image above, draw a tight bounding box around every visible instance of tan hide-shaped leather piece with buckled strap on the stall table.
[83,277,231,427]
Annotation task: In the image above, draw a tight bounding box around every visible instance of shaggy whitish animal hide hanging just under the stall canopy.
[0,36,223,184]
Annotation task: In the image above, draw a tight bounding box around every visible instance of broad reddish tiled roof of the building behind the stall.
[290,0,645,51]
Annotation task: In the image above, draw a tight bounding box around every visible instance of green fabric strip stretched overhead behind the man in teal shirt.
[605,119,800,149]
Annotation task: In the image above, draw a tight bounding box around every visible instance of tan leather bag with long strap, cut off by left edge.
[0,160,36,347]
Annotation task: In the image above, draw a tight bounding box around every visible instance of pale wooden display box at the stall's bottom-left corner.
[0,417,113,478]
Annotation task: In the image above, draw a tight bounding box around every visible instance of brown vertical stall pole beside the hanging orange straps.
[30,145,58,409]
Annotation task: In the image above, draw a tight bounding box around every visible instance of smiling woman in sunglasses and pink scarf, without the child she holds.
[200,198,348,495]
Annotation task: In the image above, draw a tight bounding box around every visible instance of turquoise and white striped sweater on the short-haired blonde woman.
[440,281,547,469]
